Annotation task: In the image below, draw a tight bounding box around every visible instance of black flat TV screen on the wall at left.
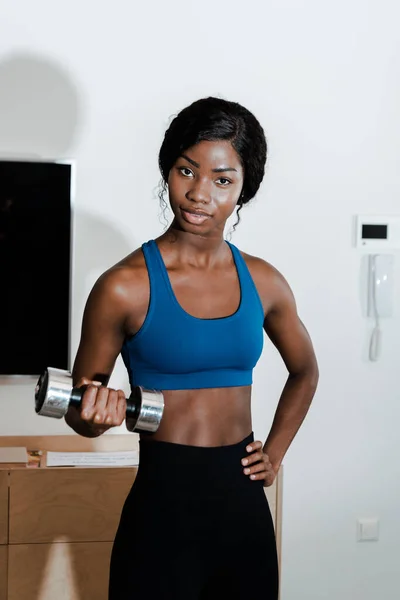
[0,160,72,375]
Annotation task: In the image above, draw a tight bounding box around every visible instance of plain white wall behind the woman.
[0,0,400,600]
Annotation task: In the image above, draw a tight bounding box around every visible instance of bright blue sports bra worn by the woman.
[121,240,264,390]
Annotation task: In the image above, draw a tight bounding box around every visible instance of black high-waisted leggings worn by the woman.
[109,434,278,600]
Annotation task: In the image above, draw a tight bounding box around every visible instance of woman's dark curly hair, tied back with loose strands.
[158,97,267,228]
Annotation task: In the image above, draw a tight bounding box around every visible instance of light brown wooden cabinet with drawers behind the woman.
[0,436,282,600]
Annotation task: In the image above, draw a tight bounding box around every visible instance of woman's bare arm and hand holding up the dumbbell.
[65,269,129,437]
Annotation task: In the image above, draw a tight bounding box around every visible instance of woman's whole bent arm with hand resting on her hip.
[242,255,318,486]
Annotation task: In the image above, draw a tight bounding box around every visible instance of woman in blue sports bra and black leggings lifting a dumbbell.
[66,98,318,600]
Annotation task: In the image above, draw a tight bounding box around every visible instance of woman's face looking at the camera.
[168,141,244,235]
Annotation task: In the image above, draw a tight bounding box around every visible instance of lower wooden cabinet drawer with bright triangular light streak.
[8,542,112,600]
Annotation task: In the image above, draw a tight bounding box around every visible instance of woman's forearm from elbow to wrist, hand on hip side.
[264,370,318,472]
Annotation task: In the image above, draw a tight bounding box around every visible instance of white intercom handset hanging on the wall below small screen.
[367,254,394,361]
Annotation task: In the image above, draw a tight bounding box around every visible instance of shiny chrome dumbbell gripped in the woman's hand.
[35,367,164,433]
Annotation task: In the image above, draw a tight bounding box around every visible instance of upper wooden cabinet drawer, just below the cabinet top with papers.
[9,468,136,544]
